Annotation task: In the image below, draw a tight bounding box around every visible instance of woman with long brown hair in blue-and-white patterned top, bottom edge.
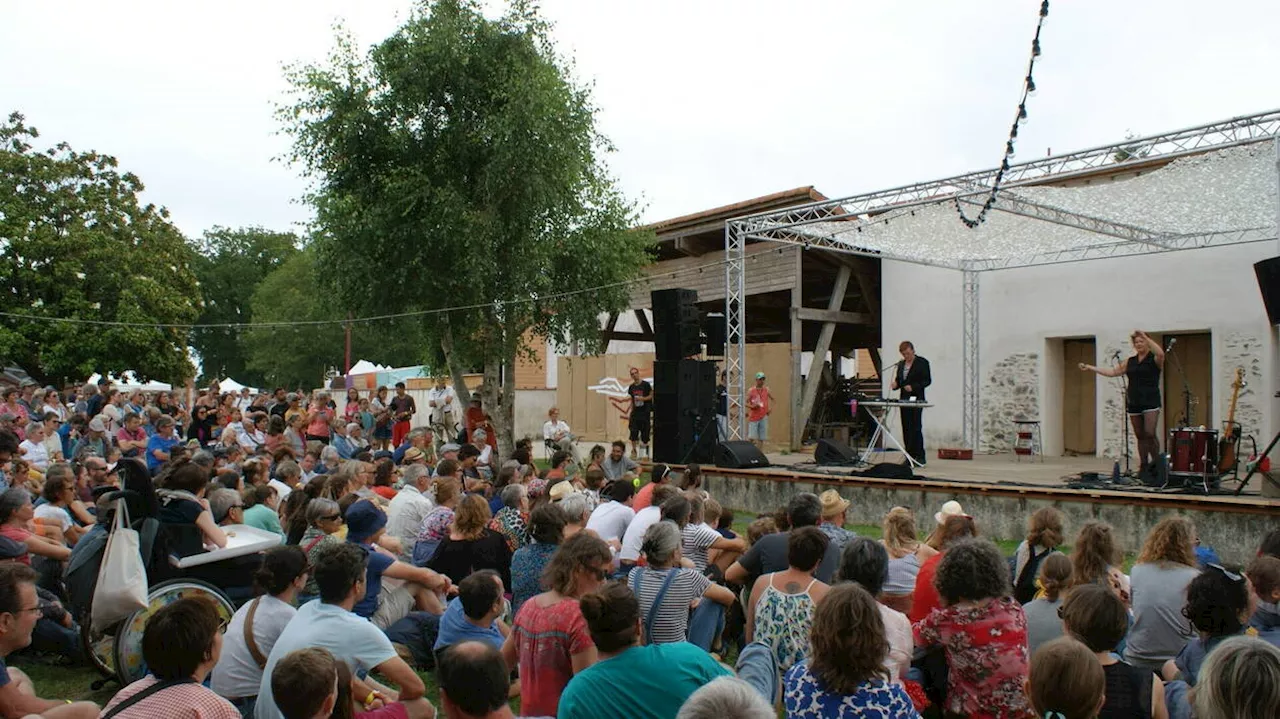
[783,582,919,719]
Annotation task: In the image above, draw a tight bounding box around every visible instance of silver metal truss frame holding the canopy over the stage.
[724,110,1280,449]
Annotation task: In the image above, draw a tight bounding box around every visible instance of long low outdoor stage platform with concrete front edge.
[703,453,1280,563]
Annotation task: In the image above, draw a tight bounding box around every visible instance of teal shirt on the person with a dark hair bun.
[556,642,733,719]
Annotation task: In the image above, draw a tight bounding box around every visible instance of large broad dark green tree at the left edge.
[0,113,200,383]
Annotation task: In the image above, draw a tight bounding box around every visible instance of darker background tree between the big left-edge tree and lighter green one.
[191,226,300,386]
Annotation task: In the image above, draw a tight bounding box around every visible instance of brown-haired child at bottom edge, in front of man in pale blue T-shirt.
[271,646,435,719]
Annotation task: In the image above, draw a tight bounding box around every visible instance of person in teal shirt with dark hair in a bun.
[557,582,731,719]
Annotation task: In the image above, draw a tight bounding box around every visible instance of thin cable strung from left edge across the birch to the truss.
[0,248,747,330]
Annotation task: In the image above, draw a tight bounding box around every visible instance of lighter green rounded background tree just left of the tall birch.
[237,247,432,388]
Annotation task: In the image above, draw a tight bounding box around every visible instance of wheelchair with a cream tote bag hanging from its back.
[65,459,236,691]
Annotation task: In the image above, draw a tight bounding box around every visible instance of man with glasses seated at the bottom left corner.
[0,562,99,719]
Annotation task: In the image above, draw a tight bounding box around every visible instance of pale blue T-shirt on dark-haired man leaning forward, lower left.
[254,600,396,719]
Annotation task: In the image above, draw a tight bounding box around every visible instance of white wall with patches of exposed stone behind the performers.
[881,242,1280,457]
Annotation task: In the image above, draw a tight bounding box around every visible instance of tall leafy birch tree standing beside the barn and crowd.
[279,0,652,448]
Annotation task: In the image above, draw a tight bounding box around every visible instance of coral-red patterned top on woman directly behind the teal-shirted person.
[511,597,595,716]
